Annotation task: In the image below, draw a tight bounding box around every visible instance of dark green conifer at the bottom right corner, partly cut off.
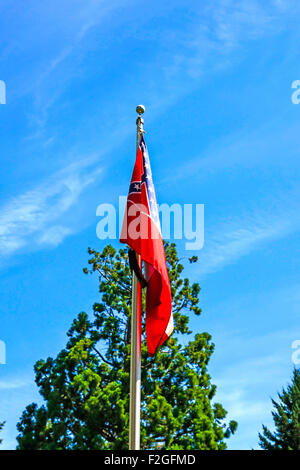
[259,369,300,450]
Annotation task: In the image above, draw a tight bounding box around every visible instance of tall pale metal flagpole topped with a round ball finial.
[129,105,145,450]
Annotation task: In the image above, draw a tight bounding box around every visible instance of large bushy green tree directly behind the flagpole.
[17,244,236,450]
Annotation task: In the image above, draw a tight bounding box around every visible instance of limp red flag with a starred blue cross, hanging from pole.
[120,137,173,356]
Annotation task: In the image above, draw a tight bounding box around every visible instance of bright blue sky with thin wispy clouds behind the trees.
[0,0,300,449]
